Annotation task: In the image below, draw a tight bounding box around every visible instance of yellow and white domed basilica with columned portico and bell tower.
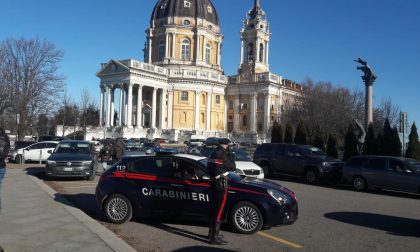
[97,0,302,142]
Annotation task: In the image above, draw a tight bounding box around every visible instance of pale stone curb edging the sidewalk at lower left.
[27,175,137,252]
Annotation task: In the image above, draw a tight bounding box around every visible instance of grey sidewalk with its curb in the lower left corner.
[0,165,136,252]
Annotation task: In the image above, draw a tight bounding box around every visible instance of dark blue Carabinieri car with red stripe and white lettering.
[95,154,298,234]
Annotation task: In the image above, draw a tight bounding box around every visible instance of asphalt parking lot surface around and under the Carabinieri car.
[16,164,420,251]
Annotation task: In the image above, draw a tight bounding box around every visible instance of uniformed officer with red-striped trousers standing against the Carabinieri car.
[207,138,236,245]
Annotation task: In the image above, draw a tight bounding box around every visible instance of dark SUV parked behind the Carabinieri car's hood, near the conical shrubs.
[254,143,344,183]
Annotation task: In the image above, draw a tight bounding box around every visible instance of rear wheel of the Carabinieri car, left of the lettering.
[104,194,133,224]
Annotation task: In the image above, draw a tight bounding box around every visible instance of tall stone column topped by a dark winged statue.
[355,58,377,131]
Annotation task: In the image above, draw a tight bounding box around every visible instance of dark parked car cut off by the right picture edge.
[343,156,420,193]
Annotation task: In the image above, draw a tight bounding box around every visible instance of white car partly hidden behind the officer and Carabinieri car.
[200,144,264,179]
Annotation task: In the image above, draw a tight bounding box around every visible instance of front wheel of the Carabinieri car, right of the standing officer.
[230,202,263,234]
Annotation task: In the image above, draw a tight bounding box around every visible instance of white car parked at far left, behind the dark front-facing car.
[11,141,58,164]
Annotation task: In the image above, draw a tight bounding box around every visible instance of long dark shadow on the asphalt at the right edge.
[324,212,420,237]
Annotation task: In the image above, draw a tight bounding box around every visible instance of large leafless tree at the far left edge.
[0,38,64,138]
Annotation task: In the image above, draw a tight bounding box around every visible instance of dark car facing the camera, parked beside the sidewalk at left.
[45,140,98,180]
